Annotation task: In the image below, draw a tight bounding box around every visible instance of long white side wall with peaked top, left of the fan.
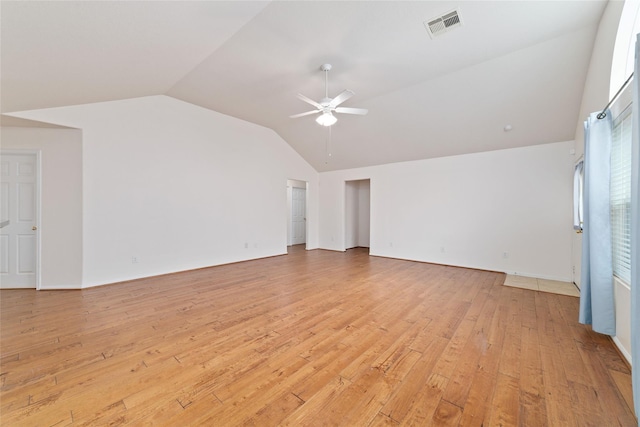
[8,96,318,287]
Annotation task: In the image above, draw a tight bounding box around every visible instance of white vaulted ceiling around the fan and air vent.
[0,0,606,171]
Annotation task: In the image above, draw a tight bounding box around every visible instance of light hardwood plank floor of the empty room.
[0,247,636,426]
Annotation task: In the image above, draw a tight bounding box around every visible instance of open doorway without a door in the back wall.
[344,179,371,250]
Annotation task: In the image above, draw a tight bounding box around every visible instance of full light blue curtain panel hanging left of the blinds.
[579,111,616,336]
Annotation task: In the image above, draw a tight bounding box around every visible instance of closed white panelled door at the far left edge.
[0,153,38,289]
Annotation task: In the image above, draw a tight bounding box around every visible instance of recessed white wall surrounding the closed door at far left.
[0,127,82,289]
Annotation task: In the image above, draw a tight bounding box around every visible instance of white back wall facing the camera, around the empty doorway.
[320,141,574,280]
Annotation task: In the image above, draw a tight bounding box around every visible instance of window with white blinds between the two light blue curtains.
[610,106,632,284]
